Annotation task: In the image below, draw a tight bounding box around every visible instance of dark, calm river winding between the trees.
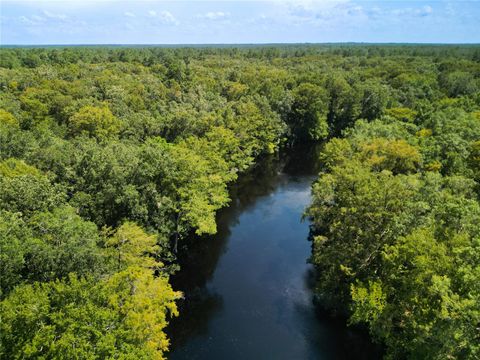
[169,149,378,360]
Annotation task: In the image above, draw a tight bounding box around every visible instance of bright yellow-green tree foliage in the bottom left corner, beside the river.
[0,266,181,360]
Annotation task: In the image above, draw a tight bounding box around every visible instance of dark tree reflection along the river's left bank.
[168,143,322,349]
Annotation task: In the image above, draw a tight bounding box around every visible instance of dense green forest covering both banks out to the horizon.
[0,44,480,359]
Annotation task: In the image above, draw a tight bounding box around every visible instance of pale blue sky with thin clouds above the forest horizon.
[0,0,480,45]
